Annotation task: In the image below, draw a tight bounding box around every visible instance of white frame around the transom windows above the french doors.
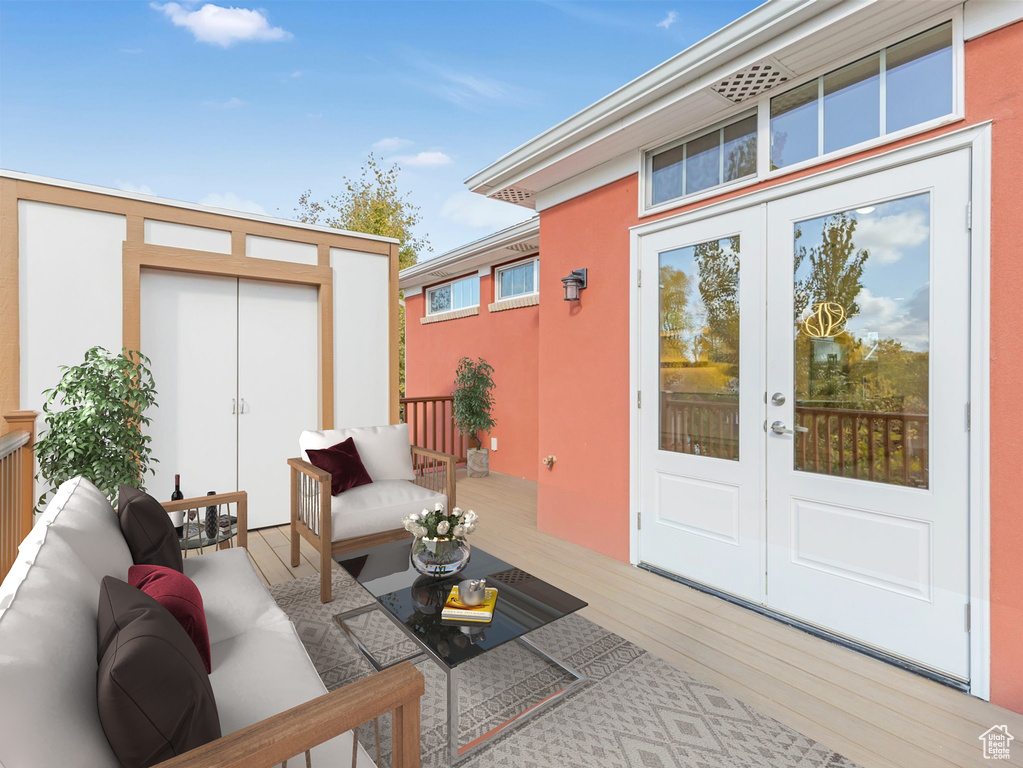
[637,6,966,218]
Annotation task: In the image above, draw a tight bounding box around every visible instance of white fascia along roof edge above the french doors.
[464,0,847,193]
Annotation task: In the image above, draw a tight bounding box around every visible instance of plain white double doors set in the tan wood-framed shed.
[140,270,319,529]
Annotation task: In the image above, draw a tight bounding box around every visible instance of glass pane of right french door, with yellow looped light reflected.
[794,193,931,488]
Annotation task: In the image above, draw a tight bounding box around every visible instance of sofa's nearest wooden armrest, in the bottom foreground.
[157,662,425,768]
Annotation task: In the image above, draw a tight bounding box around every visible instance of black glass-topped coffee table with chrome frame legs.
[335,539,586,765]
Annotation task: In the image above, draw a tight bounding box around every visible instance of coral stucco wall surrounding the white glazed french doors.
[537,22,1023,712]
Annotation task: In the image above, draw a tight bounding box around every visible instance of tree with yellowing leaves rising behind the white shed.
[295,152,433,397]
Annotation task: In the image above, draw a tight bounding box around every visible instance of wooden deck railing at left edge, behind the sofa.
[0,411,36,580]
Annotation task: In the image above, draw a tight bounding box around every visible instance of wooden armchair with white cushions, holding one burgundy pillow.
[287,424,457,602]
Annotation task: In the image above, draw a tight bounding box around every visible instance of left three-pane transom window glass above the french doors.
[651,115,757,206]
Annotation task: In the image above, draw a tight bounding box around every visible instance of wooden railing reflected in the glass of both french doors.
[661,392,928,488]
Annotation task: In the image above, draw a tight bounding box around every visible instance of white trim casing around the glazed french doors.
[629,122,991,701]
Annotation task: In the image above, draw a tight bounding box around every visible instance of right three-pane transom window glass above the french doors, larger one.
[770,22,954,170]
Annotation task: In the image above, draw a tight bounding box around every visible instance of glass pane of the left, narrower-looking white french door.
[658,235,739,461]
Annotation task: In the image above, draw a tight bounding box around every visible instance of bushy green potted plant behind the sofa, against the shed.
[36,347,157,511]
